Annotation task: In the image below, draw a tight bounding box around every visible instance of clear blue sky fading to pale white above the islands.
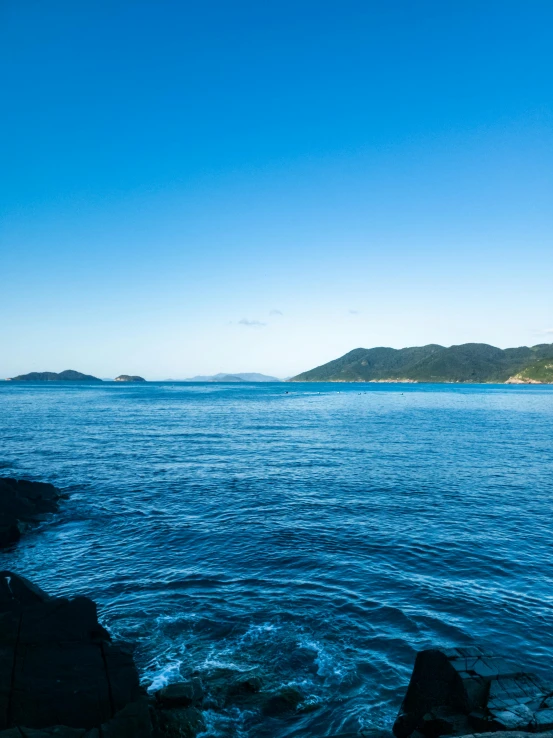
[0,0,553,379]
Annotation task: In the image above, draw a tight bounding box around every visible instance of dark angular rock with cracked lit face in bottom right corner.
[393,648,553,738]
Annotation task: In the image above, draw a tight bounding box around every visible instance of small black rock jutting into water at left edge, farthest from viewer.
[0,477,63,548]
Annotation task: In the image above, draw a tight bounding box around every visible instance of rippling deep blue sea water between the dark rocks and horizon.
[0,383,553,737]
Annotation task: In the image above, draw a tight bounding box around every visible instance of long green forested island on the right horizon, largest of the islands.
[288,343,553,384]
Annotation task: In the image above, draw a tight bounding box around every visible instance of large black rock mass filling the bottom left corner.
[0,571,152,738]
